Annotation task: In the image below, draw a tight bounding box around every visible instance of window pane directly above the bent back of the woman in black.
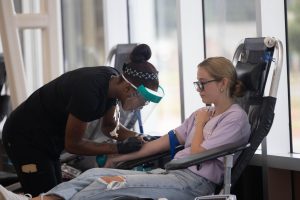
[62,0,105,71]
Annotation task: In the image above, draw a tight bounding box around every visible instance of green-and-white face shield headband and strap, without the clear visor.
[121,74,165,105]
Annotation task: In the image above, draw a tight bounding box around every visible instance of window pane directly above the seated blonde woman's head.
[204,0,256,60]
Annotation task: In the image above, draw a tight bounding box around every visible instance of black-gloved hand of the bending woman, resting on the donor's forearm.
[117,137,144,154]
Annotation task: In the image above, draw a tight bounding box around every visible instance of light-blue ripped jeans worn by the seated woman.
[46,168,216,200]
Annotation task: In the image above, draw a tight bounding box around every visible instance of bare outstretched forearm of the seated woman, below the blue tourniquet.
[104,135,170,167]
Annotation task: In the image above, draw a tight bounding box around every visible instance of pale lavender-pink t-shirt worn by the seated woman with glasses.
[174,104,250,184]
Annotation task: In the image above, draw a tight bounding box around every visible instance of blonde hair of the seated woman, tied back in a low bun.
[198,57,245,97]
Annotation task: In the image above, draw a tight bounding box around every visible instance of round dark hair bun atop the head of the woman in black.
[130,44,152,63]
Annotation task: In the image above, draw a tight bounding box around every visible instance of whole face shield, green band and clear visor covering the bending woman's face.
[122,74,164,110]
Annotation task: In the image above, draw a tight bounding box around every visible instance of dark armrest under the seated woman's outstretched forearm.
[116,145,183,169]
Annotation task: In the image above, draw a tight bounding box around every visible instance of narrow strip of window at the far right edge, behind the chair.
[287,0,300,153]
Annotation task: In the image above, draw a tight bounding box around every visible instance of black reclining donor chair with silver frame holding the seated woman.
[113,37,283,200]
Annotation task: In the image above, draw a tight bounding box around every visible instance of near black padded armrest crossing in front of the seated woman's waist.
[165,143,250,170]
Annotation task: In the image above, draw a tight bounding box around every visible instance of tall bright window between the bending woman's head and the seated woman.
[129,0,181,135]
